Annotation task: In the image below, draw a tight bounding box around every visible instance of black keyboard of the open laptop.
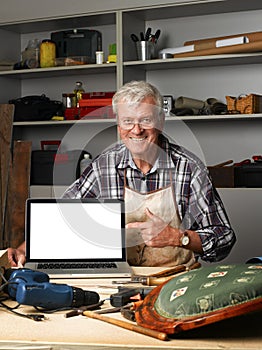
[37,262,117,270]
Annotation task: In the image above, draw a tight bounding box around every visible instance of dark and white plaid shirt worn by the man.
[63,135,236,262]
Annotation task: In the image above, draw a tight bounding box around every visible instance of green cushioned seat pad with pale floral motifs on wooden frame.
[154,264,262,319]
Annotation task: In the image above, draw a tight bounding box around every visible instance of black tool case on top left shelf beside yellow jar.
[51,29,102,63]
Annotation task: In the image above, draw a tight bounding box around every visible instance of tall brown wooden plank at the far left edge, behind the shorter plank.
[0,104,14,249]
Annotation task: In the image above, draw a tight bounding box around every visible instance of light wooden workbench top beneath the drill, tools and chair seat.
[0,280,262,350]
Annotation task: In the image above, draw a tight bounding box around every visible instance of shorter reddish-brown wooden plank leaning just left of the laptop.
[5,141,32,247]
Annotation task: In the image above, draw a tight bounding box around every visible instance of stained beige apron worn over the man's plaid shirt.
[124,171,195,266]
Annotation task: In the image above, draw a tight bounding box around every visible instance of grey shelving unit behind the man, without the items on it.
[0,0,262,262]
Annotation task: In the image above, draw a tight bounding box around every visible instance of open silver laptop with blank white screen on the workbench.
[25,198,132,278]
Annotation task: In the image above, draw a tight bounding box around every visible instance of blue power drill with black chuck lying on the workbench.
[5,268,99,310]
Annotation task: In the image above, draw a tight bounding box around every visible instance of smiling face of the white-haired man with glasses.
[118,97,164,160]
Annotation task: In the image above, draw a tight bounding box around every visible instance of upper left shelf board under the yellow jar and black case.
[0,63,116,79]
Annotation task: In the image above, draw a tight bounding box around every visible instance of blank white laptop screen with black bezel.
[26,199,126,262]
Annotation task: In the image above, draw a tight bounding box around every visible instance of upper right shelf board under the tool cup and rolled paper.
[124,52,262,71]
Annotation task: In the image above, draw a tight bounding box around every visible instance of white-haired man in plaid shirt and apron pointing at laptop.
[9,81,236,266]
